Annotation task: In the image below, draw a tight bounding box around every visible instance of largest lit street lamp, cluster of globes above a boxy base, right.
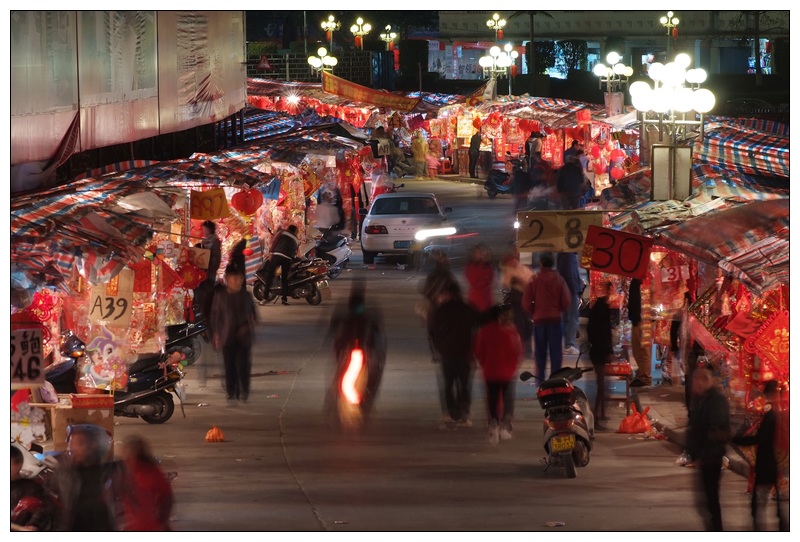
[630,53,716,201]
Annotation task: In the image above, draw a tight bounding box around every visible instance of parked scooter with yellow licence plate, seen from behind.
[520,349,594,478]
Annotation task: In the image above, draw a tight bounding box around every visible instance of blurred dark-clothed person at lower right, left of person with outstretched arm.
[686,363,731,531]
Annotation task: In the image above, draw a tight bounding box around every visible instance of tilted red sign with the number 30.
[581,226,653,280]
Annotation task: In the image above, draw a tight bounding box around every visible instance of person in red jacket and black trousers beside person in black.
[474,305,522,444]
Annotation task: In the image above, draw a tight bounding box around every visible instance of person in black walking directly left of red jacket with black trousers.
[428,282,478,429]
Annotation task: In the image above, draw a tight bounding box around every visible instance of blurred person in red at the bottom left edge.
[114,435,174,531]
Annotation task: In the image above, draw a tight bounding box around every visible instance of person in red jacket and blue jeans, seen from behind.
[522,252,571,384]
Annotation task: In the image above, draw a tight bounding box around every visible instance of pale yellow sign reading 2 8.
[517,211,603,252]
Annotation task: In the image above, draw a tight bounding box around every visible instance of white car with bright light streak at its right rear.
[359,192,455,264]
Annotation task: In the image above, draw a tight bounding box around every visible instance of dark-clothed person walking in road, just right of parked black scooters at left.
[211,264,258,403]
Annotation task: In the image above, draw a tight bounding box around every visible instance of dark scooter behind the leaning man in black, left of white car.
[253,258,329,305]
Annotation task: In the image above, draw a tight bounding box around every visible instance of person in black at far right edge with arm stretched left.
[732,380,789,532]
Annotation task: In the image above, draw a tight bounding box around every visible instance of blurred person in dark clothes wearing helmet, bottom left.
[50,424,117,532]
